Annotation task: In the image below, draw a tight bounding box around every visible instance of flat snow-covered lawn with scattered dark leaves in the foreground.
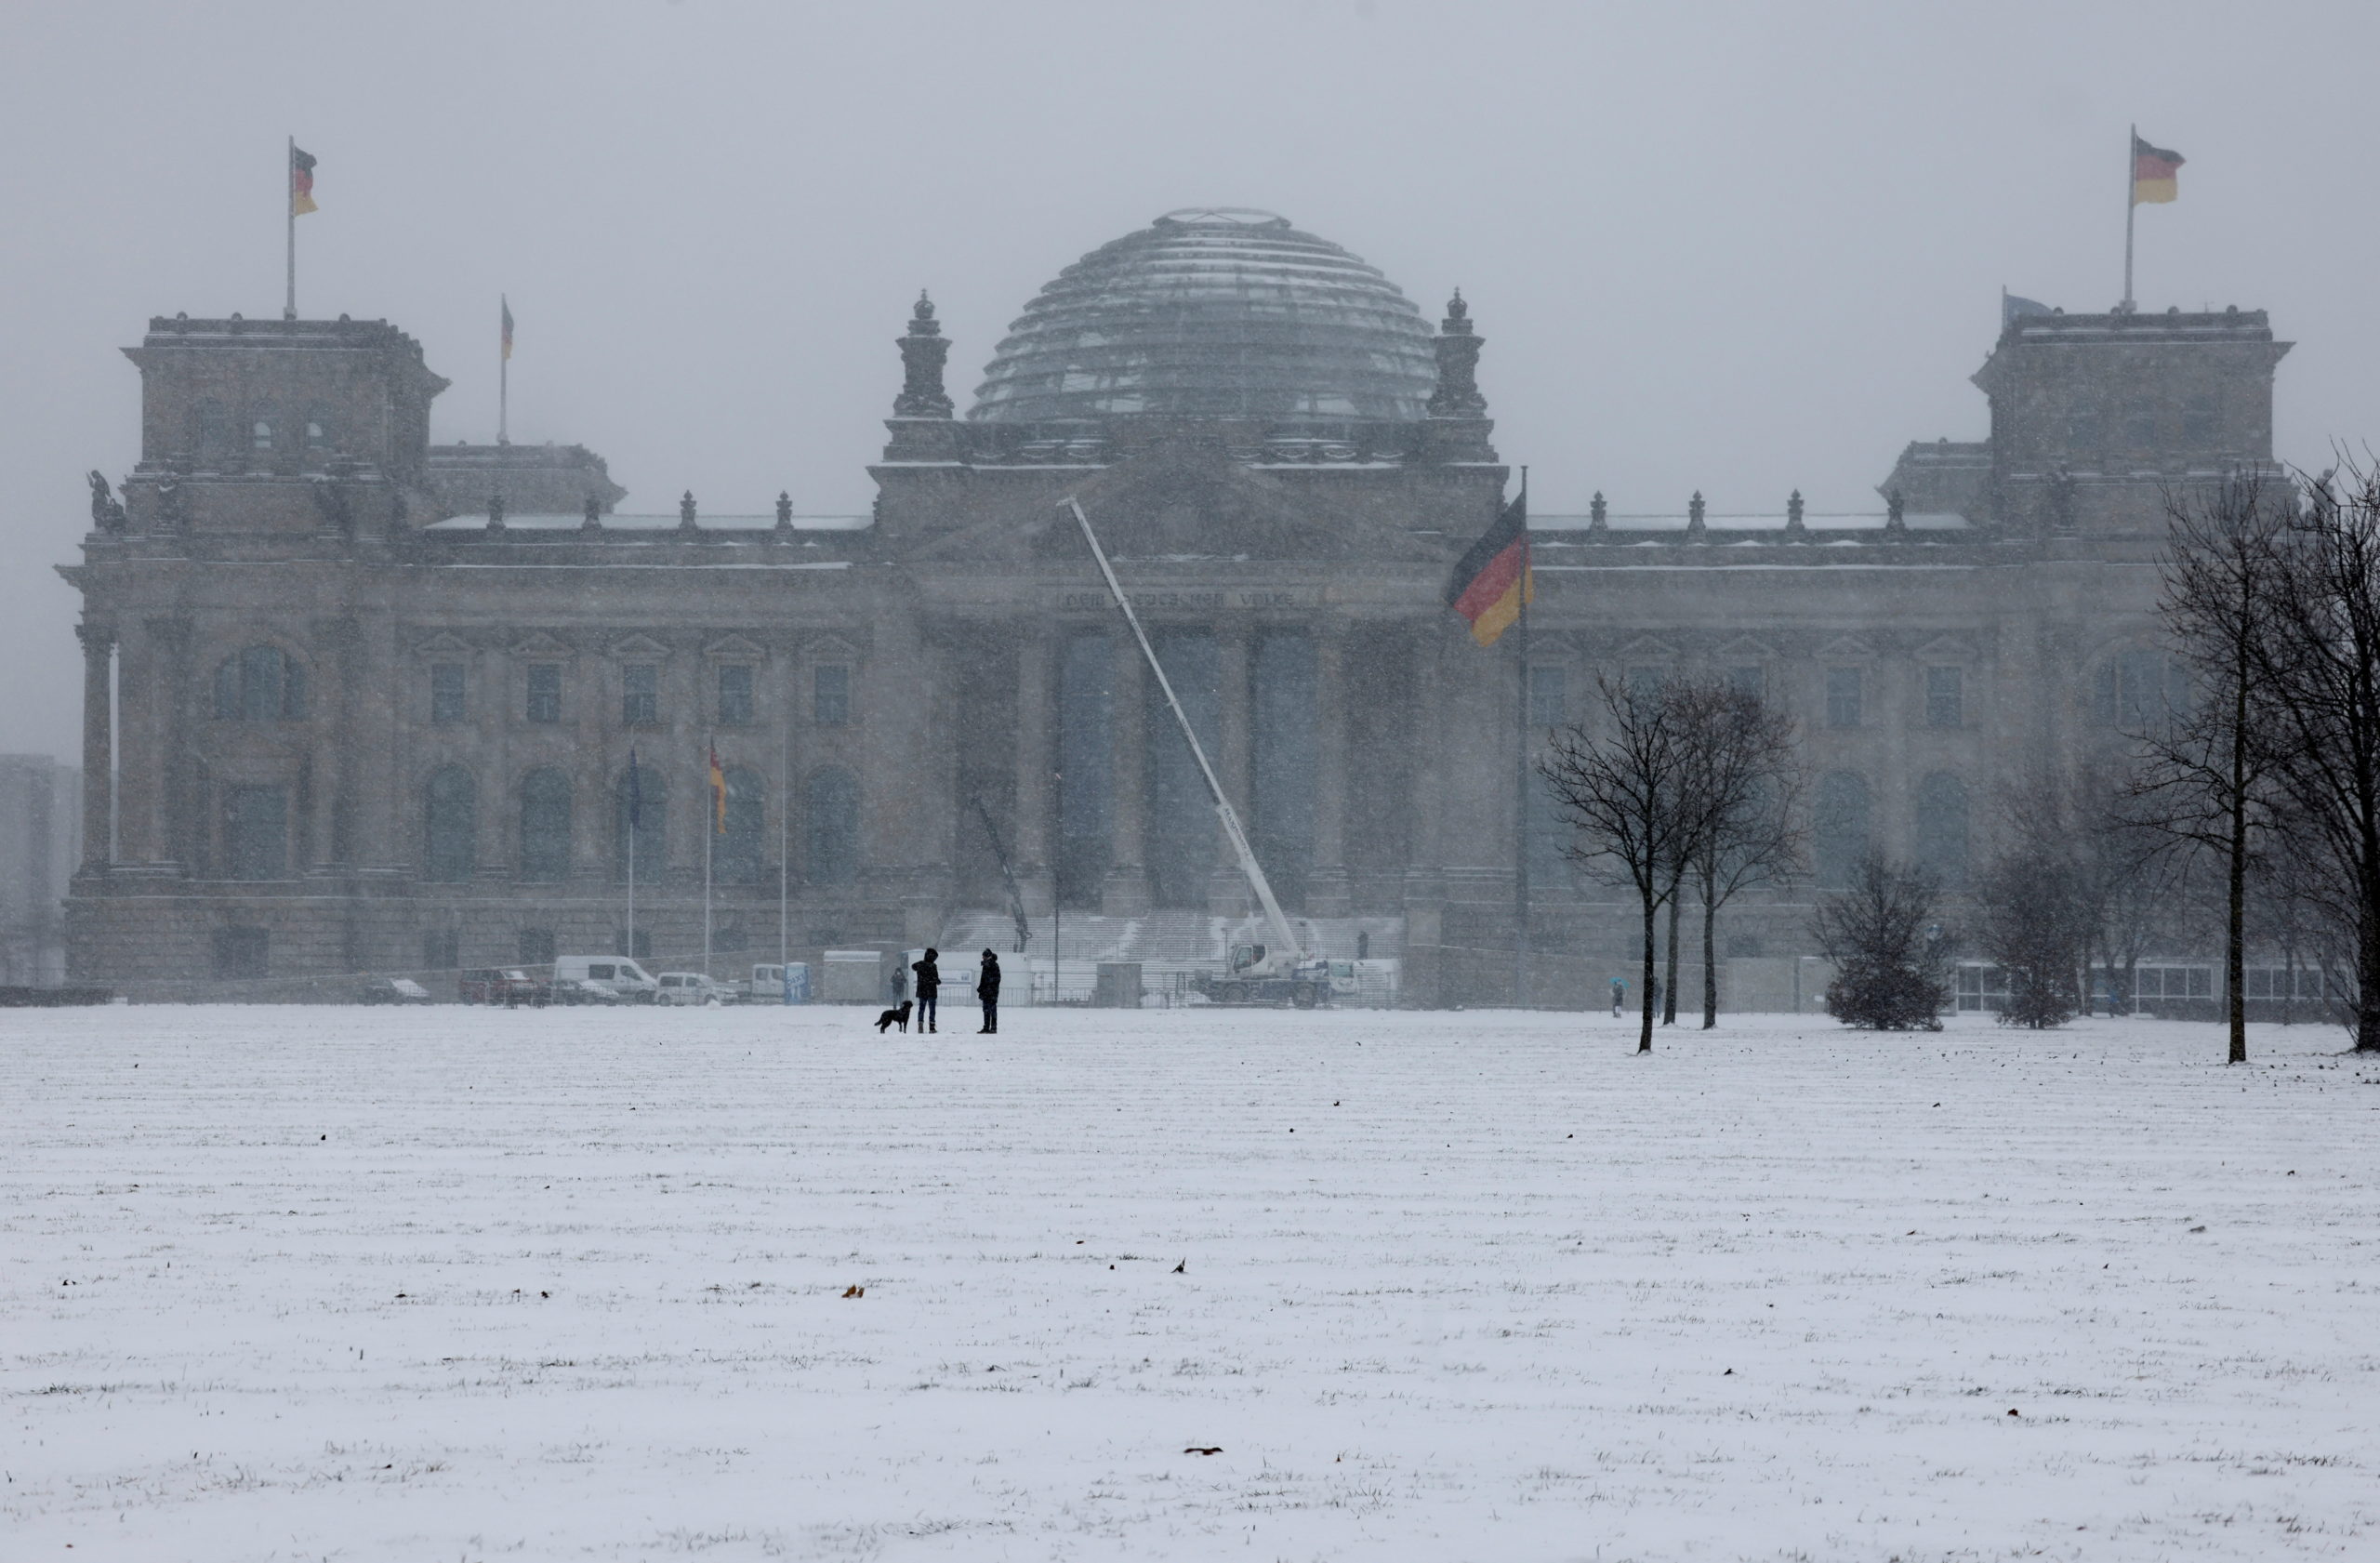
[0,1009,2380,1563]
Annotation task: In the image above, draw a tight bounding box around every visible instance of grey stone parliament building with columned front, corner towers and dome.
[51,212,2285,1004]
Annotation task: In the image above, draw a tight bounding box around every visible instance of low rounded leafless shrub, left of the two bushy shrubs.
[1809,852,1951,1030]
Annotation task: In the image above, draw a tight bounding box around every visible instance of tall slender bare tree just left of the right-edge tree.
[2130,471,2284,1064]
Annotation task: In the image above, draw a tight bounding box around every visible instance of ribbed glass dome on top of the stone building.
[966,207,1437,423]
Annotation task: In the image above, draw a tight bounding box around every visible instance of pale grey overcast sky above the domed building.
[0,0,2380,757]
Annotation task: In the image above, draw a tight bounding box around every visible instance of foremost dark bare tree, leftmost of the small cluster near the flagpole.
[1538,678,1697,1053]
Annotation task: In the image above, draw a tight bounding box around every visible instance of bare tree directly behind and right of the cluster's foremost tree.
[1669,681,1802,1030]
